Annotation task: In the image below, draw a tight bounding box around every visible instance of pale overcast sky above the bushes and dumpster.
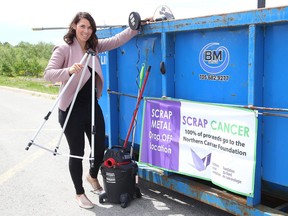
[0,0,288,45]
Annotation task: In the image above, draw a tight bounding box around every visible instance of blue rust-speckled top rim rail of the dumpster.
[97,7,288,38]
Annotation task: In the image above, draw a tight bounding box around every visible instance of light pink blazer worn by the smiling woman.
[44,28,138,111]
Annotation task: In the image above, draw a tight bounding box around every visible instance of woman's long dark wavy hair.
[63,12,98,51]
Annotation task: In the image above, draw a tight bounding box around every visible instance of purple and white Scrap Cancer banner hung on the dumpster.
[140,98,258,197]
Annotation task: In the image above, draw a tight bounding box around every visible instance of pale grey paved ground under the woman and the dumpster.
[0,87,230,216]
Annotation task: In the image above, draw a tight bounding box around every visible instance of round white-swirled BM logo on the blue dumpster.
[199,42,230,74]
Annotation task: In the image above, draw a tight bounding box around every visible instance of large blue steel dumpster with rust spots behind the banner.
[97,7,288,215]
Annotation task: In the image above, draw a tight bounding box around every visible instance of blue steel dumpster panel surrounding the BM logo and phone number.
[175,28,248,104]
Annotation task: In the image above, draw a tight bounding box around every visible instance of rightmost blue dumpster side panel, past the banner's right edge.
[262,23,288,187]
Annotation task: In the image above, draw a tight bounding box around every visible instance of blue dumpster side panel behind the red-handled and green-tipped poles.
[117,36,162,144]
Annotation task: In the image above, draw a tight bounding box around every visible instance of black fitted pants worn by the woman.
[59,100,106,194]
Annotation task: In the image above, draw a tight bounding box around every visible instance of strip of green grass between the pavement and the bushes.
[0,76,59,95]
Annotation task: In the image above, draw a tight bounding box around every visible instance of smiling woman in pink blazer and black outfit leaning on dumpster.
[44,12,142,208]
